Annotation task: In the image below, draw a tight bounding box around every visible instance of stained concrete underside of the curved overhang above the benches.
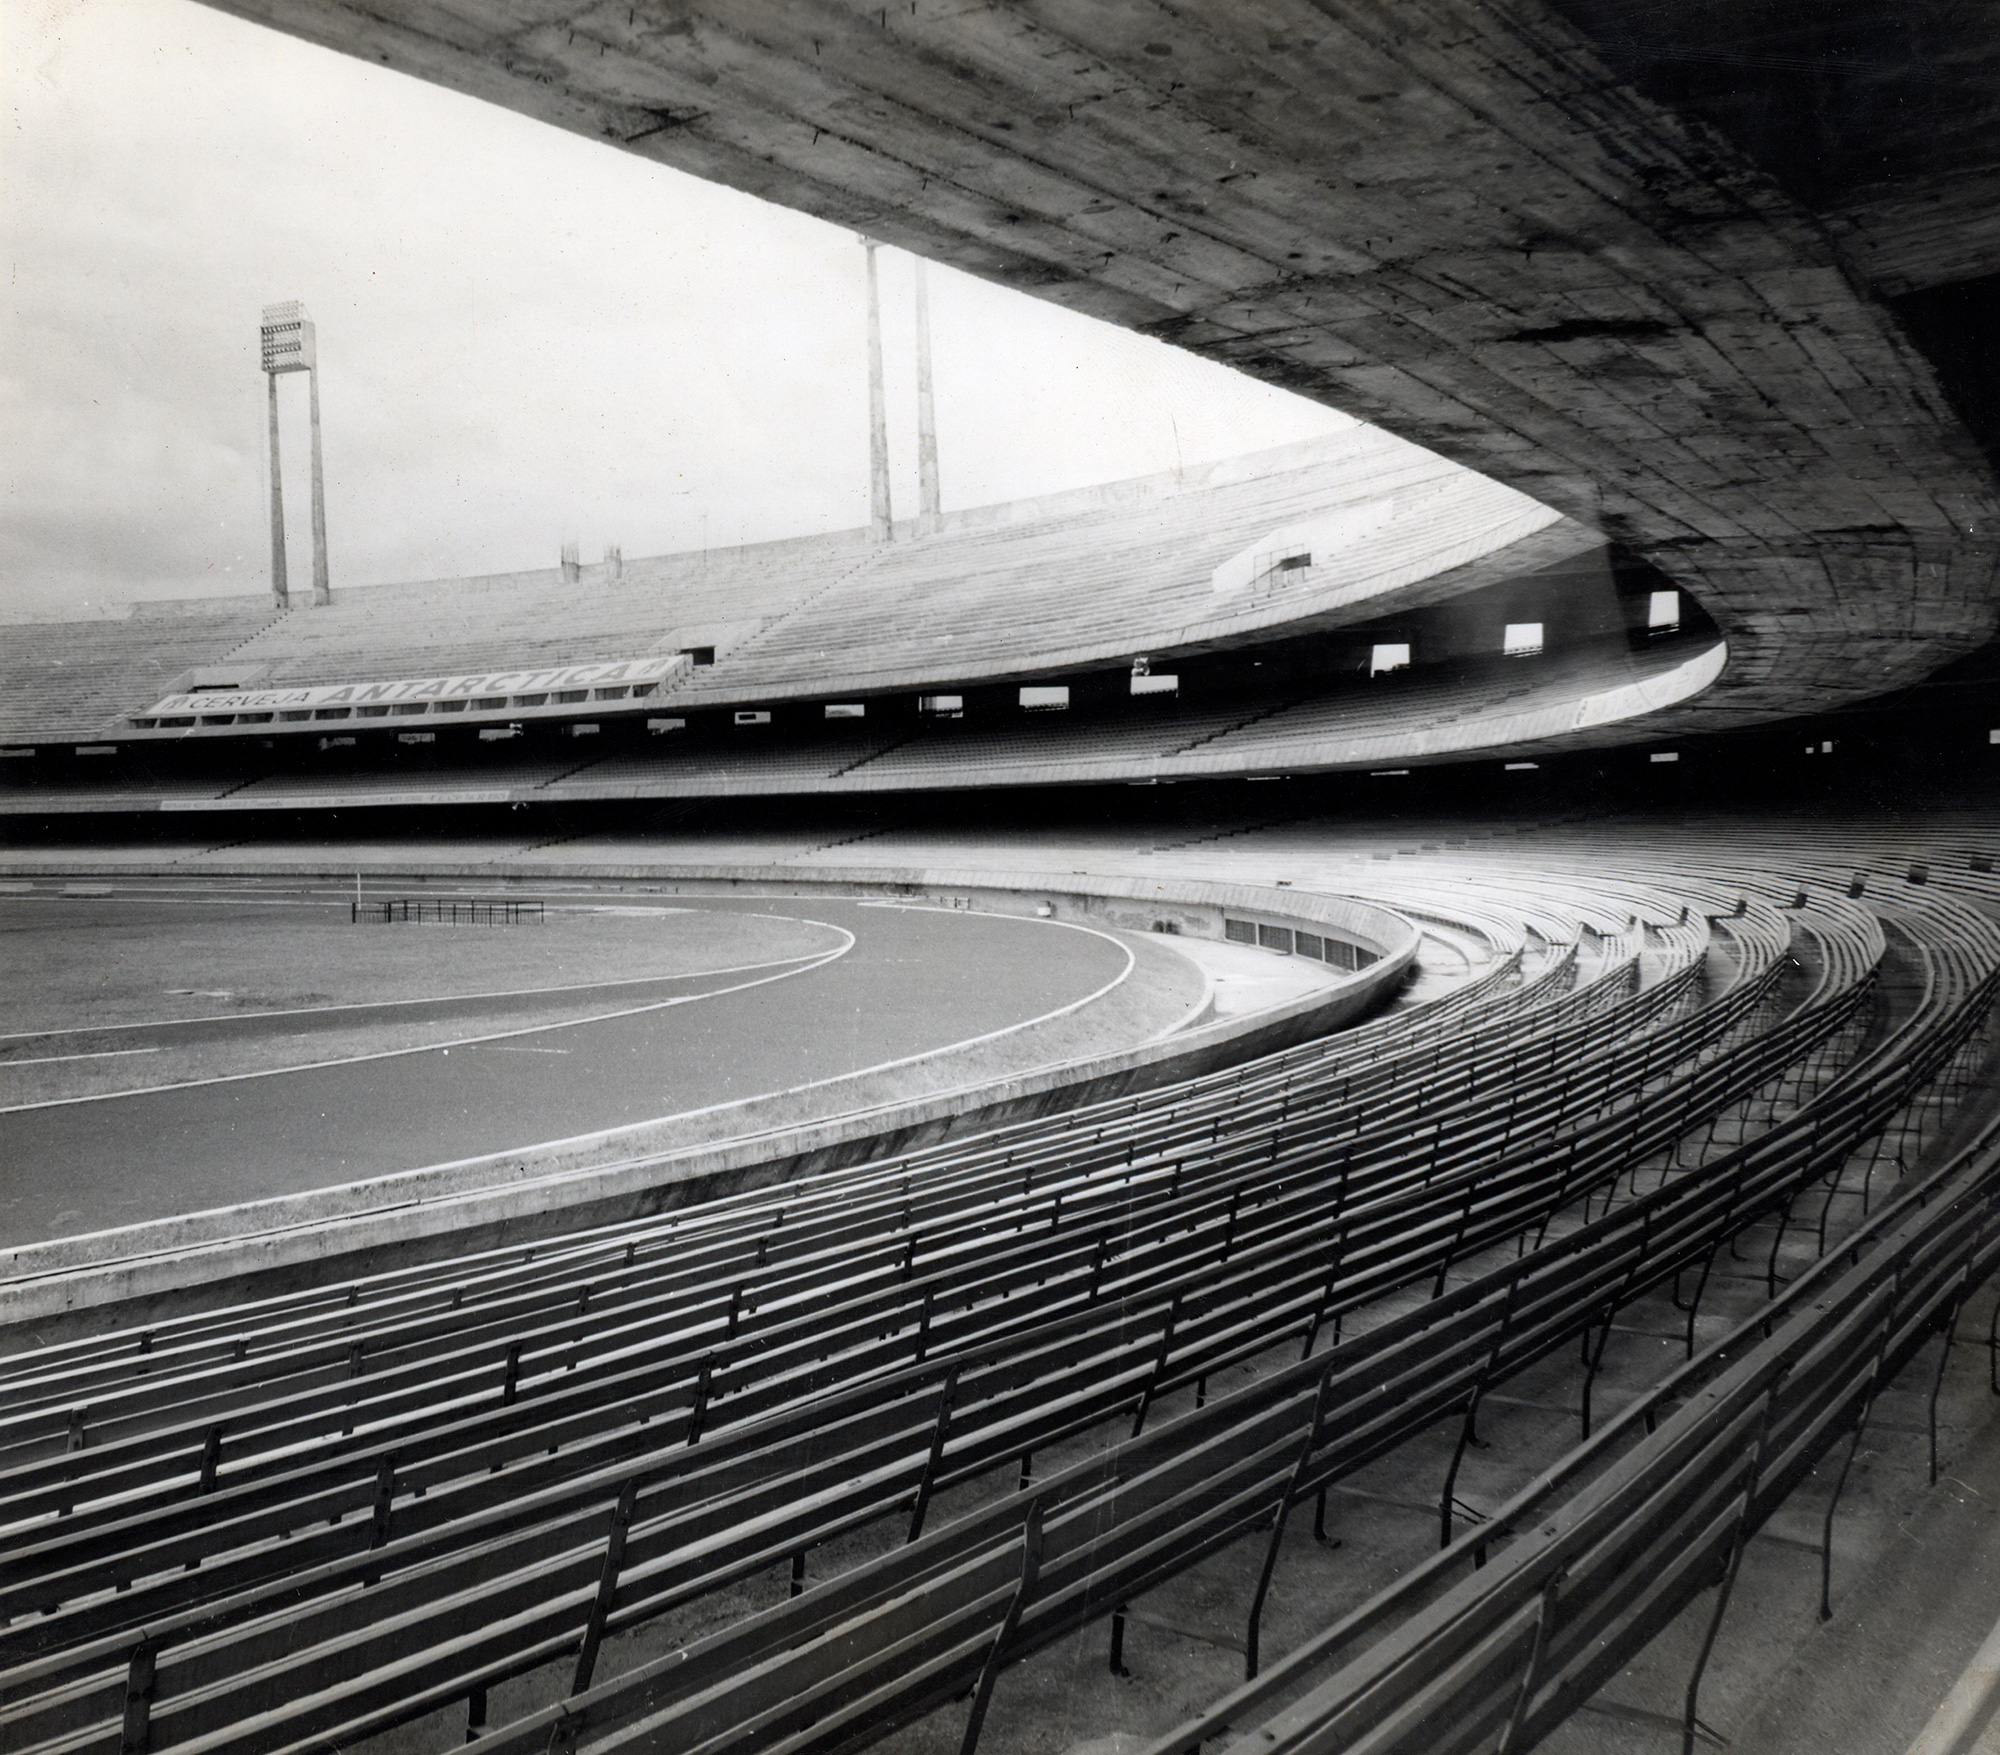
[195,0,2000,734]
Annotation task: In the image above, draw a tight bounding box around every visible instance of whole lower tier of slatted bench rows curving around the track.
[0,812,2000,1755]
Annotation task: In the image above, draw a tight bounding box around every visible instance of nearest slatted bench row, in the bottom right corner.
[1148,863,2000,1755]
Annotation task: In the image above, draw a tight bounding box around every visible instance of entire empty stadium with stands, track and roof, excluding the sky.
[0,0,2000,1755]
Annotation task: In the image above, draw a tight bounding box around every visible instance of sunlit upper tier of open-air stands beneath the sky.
[0,439,1598,742]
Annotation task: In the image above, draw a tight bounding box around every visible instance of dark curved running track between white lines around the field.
[0,897,1126,1243]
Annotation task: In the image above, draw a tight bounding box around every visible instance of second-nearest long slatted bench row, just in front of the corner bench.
[442,871,1936,1749]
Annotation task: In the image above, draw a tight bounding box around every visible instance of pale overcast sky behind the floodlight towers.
[0,0,1348,616]
